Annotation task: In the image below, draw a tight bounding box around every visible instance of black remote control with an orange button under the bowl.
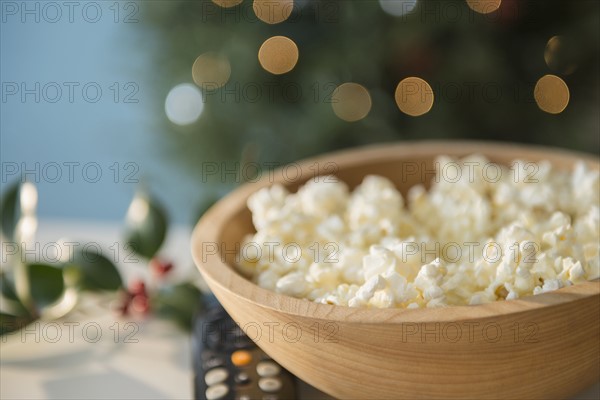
[192,296,296,400]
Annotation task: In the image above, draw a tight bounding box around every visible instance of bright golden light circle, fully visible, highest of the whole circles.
[258,36,299,75]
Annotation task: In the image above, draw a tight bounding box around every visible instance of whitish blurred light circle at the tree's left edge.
[165,83,204,125]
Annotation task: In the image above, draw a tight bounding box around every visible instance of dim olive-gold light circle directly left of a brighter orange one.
[331,82,372,122]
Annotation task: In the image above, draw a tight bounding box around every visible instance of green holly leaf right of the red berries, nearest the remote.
[152,282,201,331]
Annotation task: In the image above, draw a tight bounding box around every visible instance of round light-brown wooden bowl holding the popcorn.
[192,142,600,399]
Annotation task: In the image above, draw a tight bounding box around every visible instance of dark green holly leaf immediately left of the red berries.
[64,246,123,291]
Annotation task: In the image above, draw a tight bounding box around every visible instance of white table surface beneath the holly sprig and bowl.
[0,221,600,400]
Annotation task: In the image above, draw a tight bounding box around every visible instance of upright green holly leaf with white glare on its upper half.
[126,193,167,259]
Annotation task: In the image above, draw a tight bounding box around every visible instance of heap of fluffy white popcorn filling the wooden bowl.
[238,155,600,309]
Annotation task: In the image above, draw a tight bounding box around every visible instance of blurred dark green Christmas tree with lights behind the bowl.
[137,0,600,211]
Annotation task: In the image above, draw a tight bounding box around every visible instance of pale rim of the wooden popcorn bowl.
[191,140,600,323]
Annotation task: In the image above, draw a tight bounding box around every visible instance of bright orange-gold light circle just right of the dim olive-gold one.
[395,76,434,117]
